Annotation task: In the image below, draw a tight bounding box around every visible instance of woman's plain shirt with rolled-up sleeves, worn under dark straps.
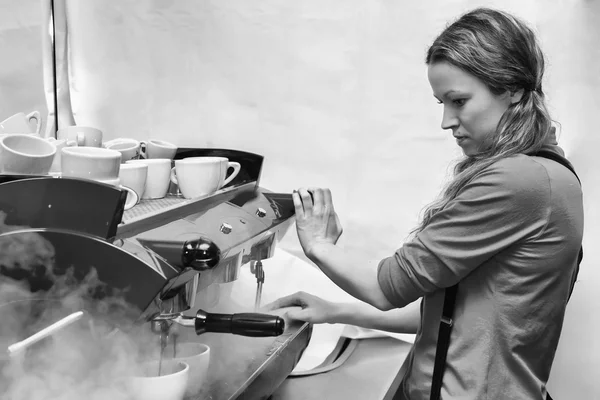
[378,145,583,400]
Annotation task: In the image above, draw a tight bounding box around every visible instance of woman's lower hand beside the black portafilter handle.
[263,292,341,324]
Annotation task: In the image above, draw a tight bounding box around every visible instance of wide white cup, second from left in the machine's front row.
[60,147,121,180]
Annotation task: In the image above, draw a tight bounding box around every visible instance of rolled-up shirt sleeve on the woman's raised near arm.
[377,156,550,307]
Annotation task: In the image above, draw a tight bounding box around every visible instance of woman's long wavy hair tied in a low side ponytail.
[412,8,552,234]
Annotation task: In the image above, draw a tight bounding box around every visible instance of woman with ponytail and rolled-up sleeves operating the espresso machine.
[272,9,583,400]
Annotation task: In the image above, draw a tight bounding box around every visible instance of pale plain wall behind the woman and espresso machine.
[0,0,600,399]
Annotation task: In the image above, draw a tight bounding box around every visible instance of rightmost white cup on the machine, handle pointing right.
[171,157,240,199]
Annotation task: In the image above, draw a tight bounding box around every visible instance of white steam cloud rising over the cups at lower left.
[0,216,159,400]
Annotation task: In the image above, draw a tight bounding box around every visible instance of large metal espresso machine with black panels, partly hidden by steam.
[0,148,311,400]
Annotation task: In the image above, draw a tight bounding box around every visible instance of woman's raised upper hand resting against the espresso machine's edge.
[292,188,343,258]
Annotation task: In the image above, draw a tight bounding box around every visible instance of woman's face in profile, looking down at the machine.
[427,62,520,156]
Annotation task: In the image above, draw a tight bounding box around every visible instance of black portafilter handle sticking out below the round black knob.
[194,310,285,337]
